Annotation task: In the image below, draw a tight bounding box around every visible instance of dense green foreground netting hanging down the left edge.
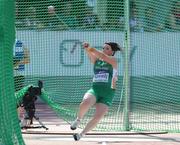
[0,0,24,145]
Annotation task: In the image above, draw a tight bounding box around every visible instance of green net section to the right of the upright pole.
[130,0,180,131]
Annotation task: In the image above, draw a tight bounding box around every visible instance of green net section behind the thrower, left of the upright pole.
[15,1,124,133]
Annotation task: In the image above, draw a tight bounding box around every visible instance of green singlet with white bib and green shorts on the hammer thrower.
[87,59,115,106]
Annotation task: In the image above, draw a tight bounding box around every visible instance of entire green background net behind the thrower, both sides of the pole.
[0,0,180,141]
